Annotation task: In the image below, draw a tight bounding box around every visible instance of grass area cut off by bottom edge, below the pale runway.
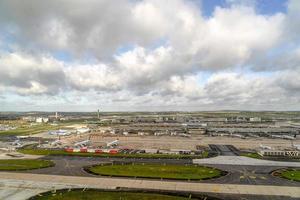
[29,190,197,200]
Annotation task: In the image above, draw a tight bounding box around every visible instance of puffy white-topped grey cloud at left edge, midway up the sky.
[0,53,65,94]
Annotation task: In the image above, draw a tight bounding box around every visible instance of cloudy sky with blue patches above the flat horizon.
[0,0,300,112]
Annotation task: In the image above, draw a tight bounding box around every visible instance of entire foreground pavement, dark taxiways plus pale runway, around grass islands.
[0,156,300,200]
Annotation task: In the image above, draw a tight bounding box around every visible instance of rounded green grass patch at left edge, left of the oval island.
[0,159,54,171]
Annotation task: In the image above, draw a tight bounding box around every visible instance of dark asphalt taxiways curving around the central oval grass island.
[12,156,300,187]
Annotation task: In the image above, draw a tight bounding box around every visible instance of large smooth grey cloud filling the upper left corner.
[0,0,164,58]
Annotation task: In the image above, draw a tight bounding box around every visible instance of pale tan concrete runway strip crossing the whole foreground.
[0,172,300,200]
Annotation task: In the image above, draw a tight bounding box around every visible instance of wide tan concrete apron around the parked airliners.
[61,133,300,150]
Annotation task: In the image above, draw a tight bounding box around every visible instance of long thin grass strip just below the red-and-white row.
[18,147,208,159]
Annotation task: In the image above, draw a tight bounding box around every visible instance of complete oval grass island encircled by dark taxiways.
[87,163,222,180]
